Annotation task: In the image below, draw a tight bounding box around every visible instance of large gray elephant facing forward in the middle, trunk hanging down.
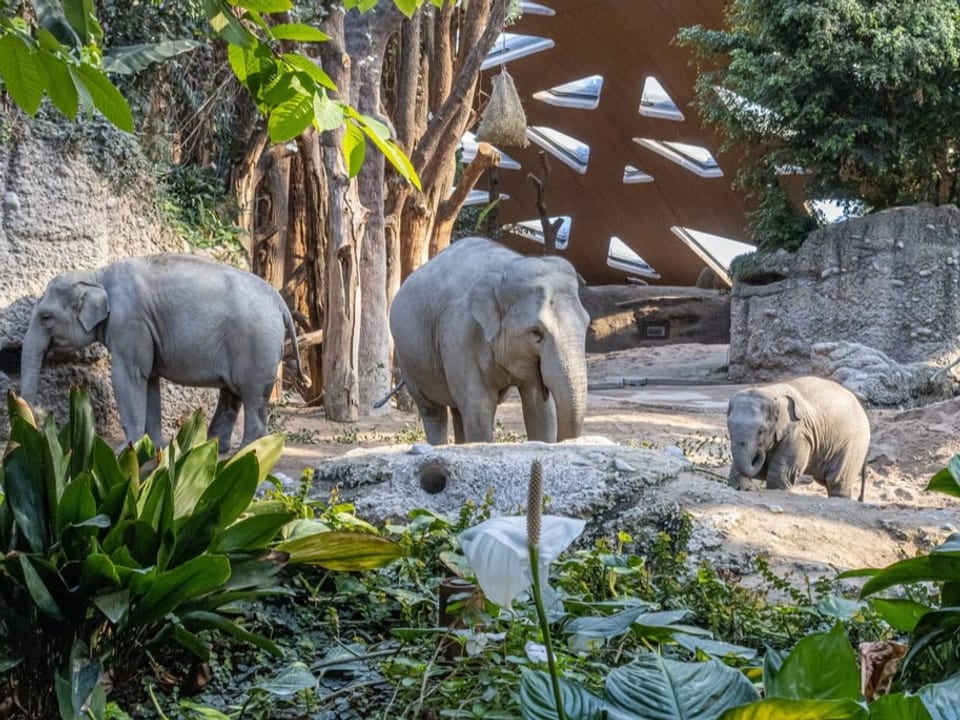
[390,237,589,445]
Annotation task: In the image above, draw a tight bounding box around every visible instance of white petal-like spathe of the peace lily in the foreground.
[460,515,586,609]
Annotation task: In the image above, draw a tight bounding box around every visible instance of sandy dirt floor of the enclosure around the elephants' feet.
[273,344,960,588]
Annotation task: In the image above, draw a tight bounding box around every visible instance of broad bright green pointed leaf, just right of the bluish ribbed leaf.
[764,623,860,700]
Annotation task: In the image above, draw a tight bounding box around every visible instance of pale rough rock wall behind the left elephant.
[0,115,216,438]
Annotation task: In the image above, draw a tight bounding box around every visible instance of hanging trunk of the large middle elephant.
[540,335,587,442]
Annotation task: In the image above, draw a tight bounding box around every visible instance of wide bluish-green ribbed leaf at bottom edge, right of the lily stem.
[605,653,759,720]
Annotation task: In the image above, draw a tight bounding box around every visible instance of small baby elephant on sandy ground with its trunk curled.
[727,376,870,501]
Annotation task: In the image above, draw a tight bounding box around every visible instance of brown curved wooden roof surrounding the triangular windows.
[482,0,746,285]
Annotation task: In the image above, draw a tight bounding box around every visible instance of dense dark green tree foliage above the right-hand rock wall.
[678,0,960,247]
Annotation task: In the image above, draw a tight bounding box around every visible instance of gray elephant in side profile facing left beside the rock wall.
[20,255,303,452]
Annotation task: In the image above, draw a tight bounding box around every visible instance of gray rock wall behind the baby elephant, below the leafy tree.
[729,205,960,382]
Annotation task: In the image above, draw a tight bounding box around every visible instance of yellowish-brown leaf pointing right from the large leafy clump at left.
[276,532,403,572]
